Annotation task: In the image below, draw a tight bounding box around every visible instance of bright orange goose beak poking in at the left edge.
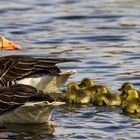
[0,36,21,50]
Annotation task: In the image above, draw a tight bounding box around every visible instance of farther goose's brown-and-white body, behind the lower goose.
[0,55,78,93]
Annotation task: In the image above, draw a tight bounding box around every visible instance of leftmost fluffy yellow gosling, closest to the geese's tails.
[65,83,91,104]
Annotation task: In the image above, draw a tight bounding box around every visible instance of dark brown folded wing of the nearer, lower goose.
[0,84,54,114]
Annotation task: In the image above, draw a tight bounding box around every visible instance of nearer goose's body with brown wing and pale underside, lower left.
[0,84,64,124]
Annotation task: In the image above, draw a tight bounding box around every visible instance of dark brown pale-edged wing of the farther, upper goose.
[0,55,78,87]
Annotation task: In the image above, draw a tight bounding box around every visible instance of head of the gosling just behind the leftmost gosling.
[79,78,94,88]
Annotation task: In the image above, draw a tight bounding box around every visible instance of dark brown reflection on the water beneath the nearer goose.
[0,124,54,140]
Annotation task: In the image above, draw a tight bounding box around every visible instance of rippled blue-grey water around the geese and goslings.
[0,0,140,140]
